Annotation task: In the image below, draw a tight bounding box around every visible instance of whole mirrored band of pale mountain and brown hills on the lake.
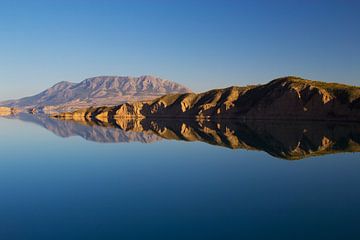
[3,113,360,160]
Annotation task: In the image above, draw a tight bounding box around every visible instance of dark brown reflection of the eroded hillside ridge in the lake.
[56,116,360,159]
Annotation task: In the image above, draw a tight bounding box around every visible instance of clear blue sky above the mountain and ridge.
[0,0,360,100]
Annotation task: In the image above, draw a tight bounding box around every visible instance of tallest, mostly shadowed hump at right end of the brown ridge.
[239,78,360,120]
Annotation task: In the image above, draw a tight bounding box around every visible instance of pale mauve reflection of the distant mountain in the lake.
[4,113,162,143]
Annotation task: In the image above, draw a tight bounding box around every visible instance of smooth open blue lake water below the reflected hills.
[0,115,360,240]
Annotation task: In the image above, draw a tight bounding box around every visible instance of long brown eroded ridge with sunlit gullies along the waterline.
[55,77,360,121]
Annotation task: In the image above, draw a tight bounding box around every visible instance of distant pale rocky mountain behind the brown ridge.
[0,75,191,112]
